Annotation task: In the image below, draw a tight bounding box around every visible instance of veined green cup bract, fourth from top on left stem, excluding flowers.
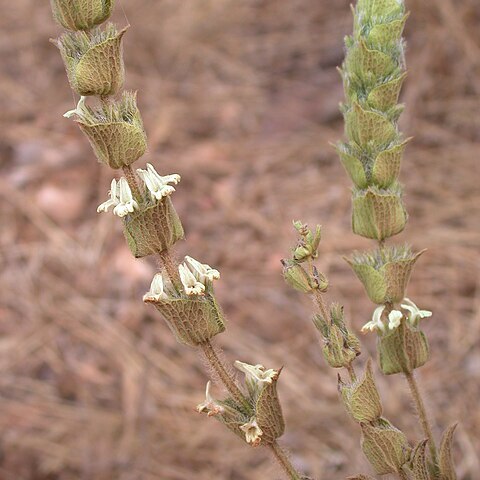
[123,196,184,258]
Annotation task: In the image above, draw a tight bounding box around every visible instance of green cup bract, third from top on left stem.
[76,92,147,169]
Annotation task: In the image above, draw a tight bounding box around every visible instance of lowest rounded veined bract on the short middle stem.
[360,418,411,475]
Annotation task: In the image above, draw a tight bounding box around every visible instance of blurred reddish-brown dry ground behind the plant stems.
[0,0,480,480]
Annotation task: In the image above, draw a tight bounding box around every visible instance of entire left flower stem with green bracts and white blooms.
[47,0,305,480]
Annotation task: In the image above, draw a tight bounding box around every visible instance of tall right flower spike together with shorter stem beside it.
[283,0,456,480]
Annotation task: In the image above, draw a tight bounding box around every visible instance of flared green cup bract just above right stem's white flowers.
[345,246,425,305]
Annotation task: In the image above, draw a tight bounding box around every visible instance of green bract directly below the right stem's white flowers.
[378,321,429,375]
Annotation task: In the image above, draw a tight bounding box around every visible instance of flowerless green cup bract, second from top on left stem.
[54,23,127,97]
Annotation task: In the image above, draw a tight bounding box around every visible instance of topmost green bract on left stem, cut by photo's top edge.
[50,0,114,30]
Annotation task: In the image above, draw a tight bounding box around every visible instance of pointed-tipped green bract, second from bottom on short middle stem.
[339,360,382,423]
